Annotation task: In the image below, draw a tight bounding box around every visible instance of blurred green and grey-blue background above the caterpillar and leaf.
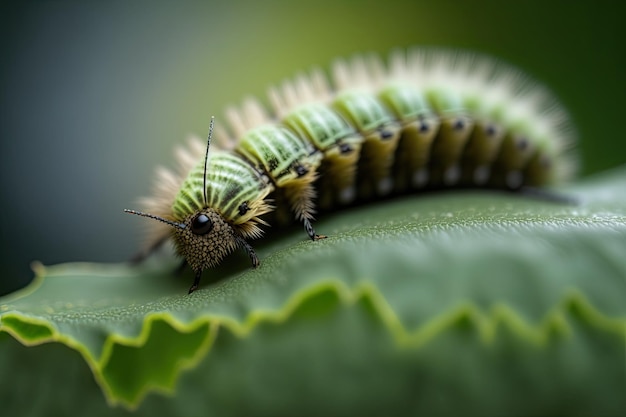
[0,0,626,294]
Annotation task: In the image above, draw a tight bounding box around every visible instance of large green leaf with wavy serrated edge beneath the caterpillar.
[0,168,626,415]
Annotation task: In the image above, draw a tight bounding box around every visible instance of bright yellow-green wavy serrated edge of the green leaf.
[0,266,626,410]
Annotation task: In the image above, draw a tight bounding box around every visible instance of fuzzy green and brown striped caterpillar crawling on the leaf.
[125,48,576,293]
